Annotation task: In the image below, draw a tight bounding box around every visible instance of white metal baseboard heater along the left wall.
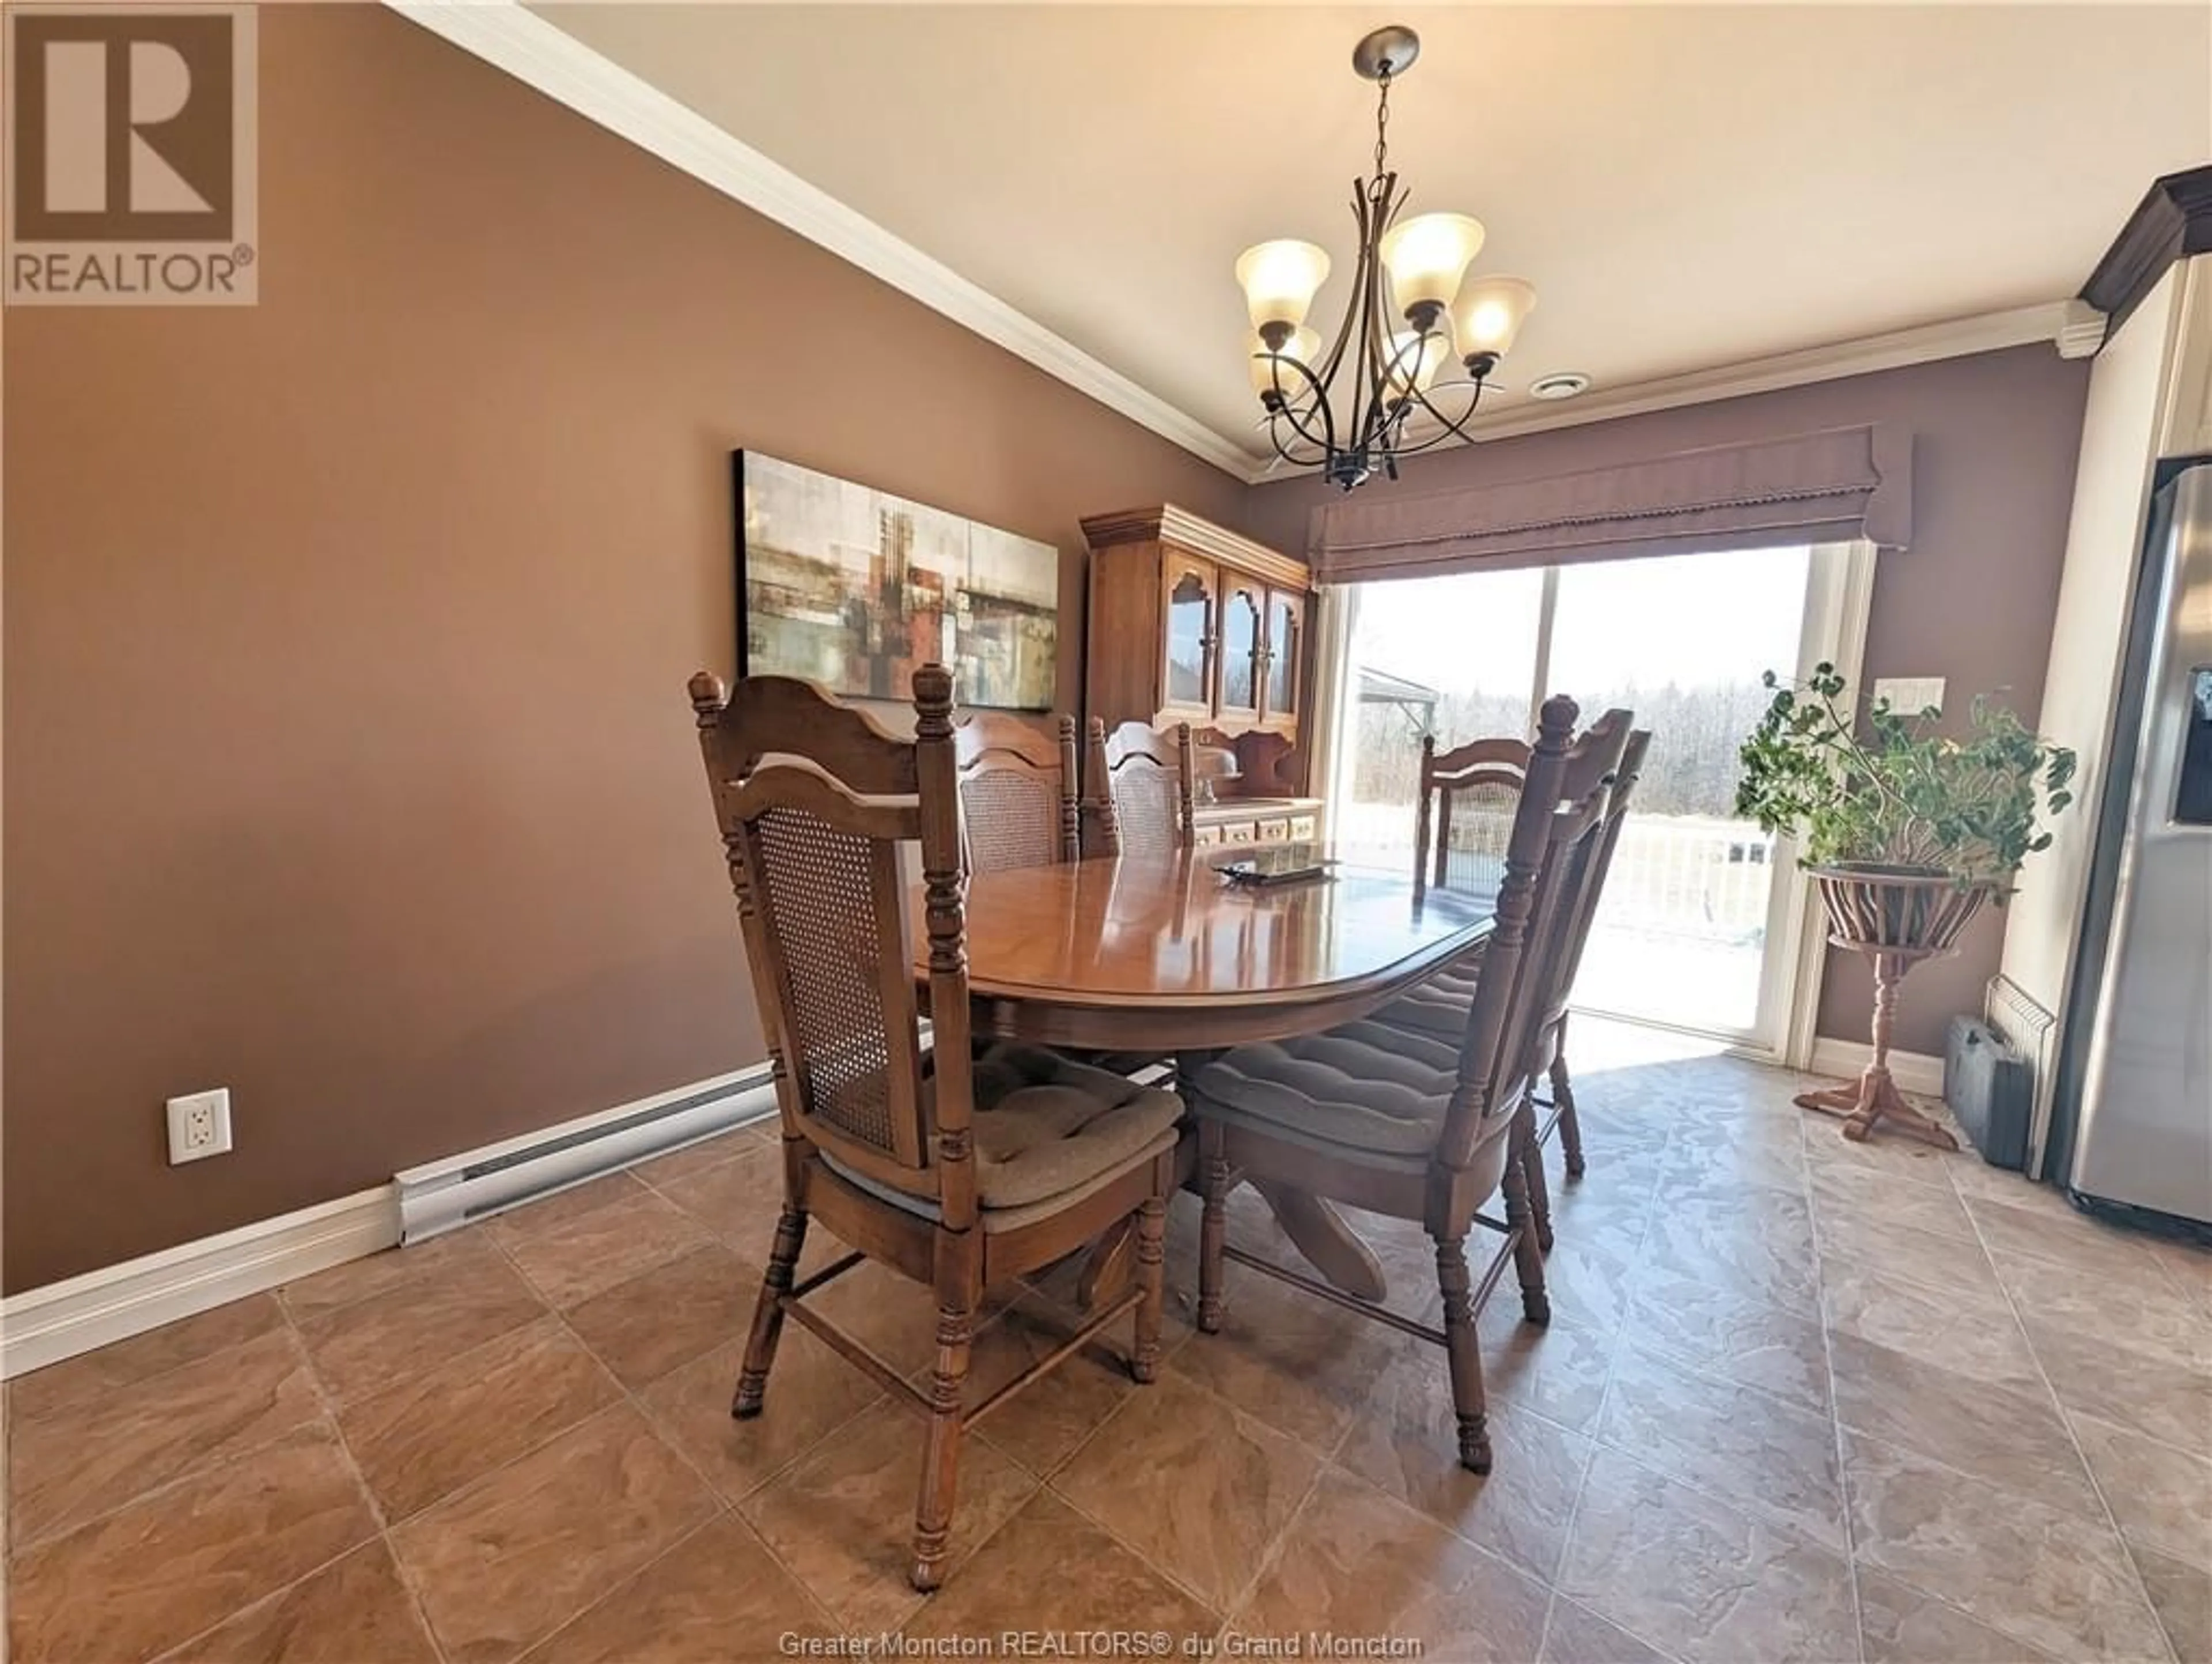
[392,1062,777,1243]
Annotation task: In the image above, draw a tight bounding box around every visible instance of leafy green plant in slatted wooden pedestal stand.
[1736,664,2075,1148]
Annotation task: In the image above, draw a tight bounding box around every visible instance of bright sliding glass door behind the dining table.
[1334,547,1856,1053]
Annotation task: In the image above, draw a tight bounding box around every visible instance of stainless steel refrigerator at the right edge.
[2046,458,2212,1224]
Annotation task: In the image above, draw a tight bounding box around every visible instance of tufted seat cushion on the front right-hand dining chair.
[1192,1022,1460,1159]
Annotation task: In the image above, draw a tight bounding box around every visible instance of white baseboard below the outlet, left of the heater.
[0,1184,400,1379]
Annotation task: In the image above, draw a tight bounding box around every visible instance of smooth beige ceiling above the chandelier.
[533,2,2212,464]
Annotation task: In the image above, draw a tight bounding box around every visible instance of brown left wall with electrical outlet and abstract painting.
[5,5,1243,1290]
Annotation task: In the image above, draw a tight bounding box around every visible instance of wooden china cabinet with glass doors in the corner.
[1084,505,1320,843]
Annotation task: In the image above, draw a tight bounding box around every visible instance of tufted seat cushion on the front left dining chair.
[975,1045,1183,1208]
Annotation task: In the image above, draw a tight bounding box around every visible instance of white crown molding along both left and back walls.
[385,0,2104,485]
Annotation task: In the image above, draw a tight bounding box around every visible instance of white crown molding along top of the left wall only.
[385,0,1252,478]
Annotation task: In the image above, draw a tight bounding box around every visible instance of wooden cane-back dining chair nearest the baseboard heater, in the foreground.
[690,664,1183,1591]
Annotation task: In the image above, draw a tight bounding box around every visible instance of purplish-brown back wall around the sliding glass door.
[1245,347,2088,1051]
